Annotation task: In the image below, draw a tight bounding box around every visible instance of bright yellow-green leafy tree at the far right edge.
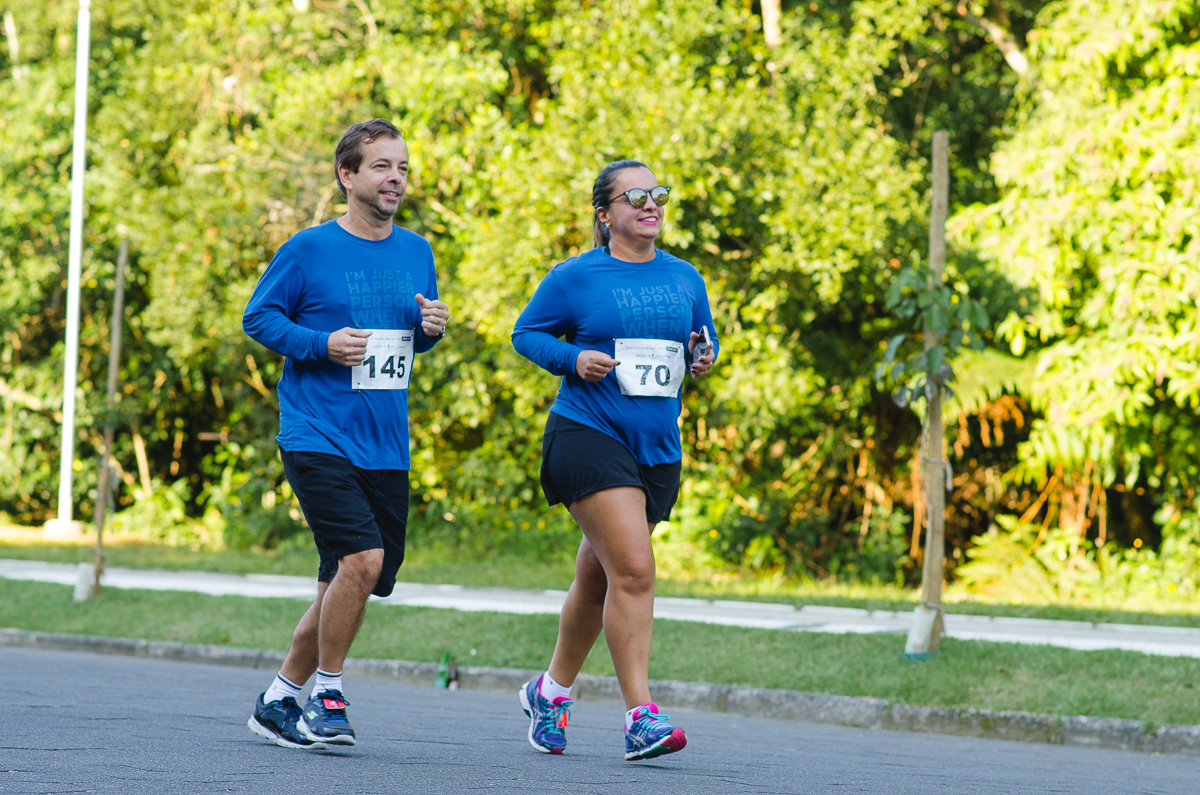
[958,0,1200,574]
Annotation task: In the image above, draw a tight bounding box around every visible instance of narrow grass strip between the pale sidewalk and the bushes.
[0,539,1200,627]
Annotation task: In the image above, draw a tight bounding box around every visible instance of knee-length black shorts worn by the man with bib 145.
[280,450,408,596]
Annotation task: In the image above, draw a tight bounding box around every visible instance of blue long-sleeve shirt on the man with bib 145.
[242,220,438,470]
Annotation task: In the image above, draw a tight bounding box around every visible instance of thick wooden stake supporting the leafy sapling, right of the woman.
[905,131,950,654]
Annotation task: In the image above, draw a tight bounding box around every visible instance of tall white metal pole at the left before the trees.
[58,0,91,532]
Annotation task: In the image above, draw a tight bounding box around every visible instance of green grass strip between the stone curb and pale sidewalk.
[0,580,1200,725]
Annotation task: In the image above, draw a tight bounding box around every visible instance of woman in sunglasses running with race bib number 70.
[512,160,716,760]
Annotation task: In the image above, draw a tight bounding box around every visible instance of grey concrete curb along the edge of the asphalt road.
[0,629,1200,755]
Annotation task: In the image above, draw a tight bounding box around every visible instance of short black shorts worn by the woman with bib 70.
[541,412,683,524]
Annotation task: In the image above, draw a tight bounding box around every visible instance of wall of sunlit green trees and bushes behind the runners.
[7,0,1200,582]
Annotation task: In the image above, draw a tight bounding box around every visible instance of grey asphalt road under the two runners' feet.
[0,648,1200,795]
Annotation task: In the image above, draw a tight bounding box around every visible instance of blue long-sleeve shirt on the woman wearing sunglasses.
[512,249,718,466]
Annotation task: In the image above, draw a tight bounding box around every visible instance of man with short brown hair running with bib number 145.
[242,119,450,748]
